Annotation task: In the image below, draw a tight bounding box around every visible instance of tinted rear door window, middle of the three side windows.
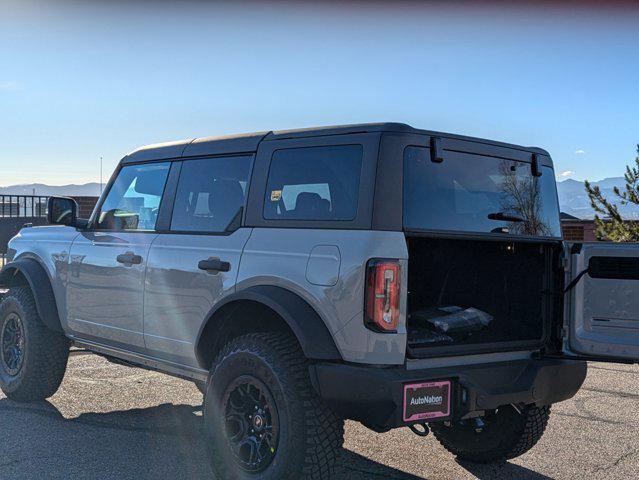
[171,156,252,233]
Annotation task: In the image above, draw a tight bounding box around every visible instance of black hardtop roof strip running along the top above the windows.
[122,122,548,163]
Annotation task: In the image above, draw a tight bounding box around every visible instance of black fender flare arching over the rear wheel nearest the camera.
[195,285,342,361]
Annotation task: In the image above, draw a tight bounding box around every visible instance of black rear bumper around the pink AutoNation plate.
[311,359,587,431]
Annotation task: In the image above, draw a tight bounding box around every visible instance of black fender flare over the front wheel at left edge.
[0,258,63,332]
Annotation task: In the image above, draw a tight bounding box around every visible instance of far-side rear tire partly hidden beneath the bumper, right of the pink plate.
[430,405,550,463]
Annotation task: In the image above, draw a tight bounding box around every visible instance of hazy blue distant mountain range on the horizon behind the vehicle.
[0,177,639,219]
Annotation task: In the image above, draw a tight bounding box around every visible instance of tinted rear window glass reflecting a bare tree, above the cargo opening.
[404,147,561,237]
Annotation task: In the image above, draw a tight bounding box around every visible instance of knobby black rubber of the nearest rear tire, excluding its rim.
[204,333,344,480]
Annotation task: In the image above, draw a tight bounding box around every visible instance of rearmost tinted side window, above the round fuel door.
[264,145,363,221]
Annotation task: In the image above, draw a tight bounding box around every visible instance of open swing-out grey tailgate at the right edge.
[564,242,639,362]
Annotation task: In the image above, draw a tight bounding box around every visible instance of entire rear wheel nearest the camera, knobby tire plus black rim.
[204,333,344,480]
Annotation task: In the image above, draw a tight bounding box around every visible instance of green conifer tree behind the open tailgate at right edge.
[585,144,639,242]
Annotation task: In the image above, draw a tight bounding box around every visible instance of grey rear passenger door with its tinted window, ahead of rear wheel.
[144,155,253,366]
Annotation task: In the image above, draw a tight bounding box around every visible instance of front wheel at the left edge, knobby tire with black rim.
[0,287,69,402]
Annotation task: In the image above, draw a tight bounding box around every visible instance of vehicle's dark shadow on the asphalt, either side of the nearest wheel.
[0,399,419,480]
